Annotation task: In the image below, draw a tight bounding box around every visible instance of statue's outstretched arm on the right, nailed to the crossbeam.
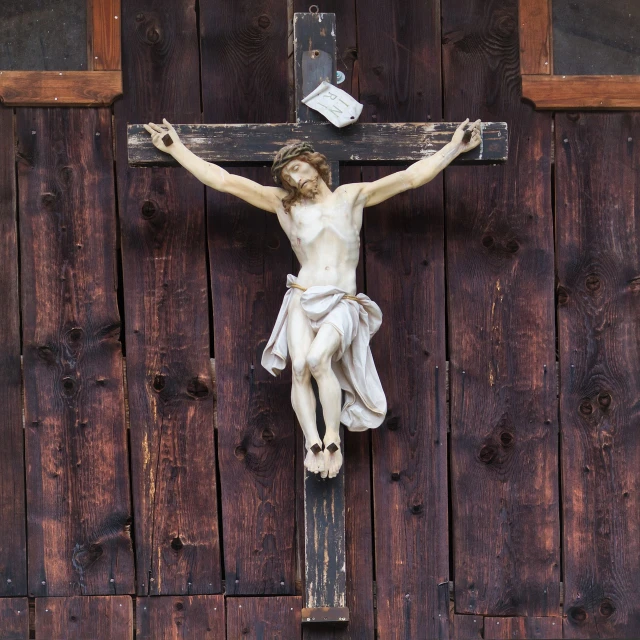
[358,118,481,207]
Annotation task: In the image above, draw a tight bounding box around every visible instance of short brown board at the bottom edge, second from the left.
[36,596,133,640]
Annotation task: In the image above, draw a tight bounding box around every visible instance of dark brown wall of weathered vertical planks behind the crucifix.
[0,0,640,640]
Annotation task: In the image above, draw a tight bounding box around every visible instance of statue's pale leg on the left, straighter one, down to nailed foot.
[287,294,326,474]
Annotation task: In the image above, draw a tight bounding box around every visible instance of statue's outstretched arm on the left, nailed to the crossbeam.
[144,119,286,213]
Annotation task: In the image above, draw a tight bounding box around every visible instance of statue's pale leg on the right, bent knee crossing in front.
[307,324,342,478]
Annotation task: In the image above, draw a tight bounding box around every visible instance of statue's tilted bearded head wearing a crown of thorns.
[271,142,331,213]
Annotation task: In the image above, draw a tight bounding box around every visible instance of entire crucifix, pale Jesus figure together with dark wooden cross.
[128,10,507,624]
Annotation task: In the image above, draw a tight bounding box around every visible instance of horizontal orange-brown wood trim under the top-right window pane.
[522,75,640,109]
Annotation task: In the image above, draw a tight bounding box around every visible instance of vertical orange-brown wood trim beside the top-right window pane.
[518,0,553,75]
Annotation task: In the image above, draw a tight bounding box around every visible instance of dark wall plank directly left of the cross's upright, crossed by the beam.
[200,0,295,596]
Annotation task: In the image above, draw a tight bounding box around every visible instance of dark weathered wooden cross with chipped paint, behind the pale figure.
[128,12,507,625]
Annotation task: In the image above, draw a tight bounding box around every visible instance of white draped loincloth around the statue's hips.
[262,274,387,431]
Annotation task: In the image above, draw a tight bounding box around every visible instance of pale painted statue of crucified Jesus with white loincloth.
[144,118,481,478]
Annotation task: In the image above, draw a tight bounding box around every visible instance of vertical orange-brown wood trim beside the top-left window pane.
[89,0,122,71]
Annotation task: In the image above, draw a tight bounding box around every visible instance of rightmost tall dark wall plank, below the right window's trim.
[556,114,640,638]
